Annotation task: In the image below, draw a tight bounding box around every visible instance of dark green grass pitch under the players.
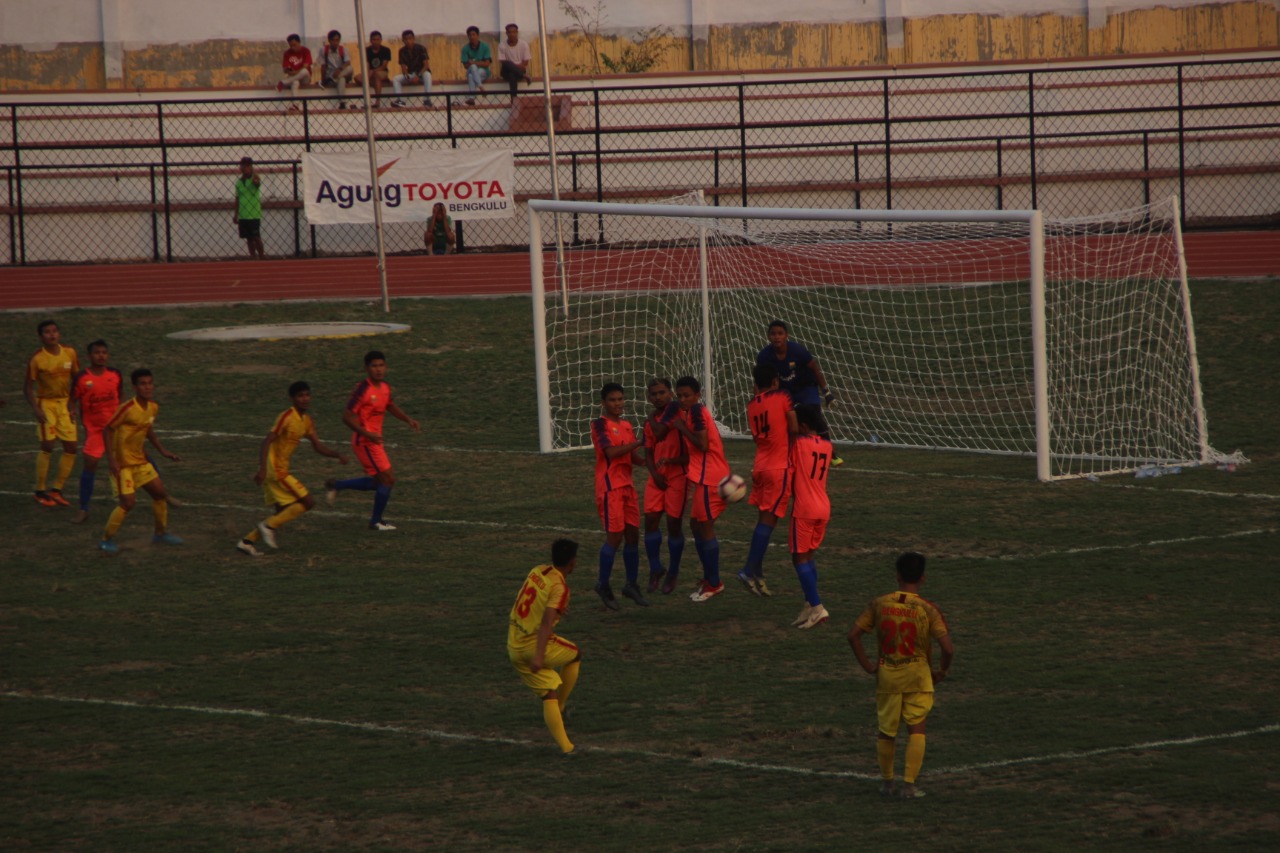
[0,282,1280,850]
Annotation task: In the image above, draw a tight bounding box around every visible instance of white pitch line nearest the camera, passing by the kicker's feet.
[0,690,1280,781]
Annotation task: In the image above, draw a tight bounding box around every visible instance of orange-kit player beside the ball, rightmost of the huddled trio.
[663,377,728,602]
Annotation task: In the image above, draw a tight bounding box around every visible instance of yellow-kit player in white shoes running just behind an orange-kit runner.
[236,382,347,557]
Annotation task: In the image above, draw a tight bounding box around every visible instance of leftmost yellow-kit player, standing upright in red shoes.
[22,320,79,506]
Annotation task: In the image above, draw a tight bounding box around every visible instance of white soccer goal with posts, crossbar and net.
[529,200,1244,480]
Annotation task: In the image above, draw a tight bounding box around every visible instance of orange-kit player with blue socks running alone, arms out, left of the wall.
[324,350,421,530]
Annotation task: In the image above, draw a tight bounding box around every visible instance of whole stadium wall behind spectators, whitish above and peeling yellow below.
[0,0,1280,92]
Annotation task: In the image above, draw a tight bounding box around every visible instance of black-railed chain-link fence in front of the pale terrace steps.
[0,59,1280,264]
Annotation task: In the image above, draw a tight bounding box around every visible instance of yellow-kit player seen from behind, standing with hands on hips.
[849,552,955,799]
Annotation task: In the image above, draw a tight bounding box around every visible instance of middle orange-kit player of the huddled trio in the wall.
[644,377,689,593]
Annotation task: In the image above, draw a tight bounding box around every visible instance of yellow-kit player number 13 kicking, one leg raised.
[507,539,581,754]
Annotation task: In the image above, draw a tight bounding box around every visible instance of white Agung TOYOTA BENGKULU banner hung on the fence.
[302,149,516,225]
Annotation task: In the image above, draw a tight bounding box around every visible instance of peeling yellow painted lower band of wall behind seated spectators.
[0,0,1280,91]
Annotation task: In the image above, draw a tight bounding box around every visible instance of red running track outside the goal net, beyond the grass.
[0,231,1280,311]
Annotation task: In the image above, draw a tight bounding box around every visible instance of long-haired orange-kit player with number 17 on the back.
[788,409,835,629]
